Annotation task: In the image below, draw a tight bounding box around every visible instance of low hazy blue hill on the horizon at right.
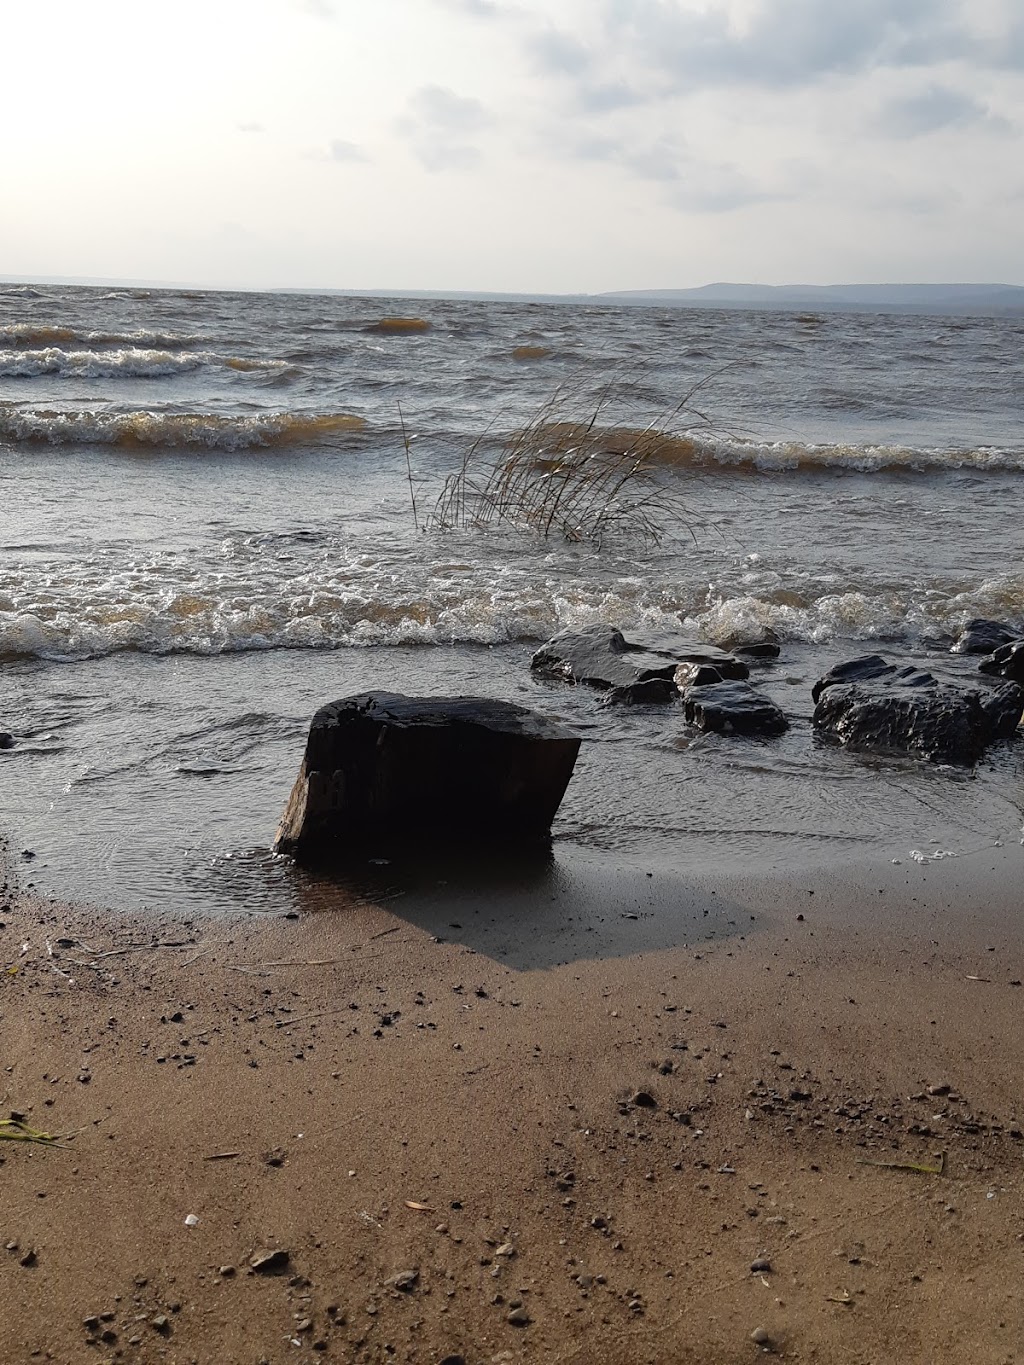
[591,284,1024,315]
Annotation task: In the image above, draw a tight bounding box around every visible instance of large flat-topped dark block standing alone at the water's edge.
[274,692,580,857]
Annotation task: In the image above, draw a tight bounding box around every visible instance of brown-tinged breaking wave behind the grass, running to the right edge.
[546,422,1024,474]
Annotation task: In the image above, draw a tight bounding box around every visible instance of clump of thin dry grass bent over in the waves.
[426,379,731,545]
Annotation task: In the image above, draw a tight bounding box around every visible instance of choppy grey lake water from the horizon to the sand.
[0,287,1024,905]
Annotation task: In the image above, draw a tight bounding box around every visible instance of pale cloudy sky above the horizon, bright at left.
[0,0,1024,293]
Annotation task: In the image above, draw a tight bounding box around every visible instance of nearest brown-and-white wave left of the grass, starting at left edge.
[0,404,366,450]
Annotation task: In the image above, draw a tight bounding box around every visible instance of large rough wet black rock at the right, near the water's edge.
[812,655,1024,766]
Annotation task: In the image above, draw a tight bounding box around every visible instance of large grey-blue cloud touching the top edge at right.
[605,0,984,90]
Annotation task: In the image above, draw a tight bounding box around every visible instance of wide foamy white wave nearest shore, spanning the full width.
[0,545,1024,661]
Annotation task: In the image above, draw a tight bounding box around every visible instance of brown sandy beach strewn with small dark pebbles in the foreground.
[0,848,1024,1365]
